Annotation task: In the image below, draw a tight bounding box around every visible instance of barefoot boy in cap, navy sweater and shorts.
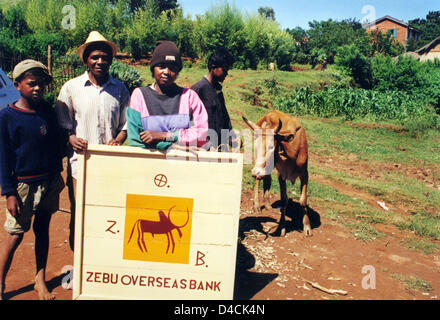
[0,60,64,300]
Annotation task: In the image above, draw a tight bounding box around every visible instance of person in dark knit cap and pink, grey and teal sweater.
[126,41,208,150]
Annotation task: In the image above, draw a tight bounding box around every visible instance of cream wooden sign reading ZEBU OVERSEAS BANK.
[73,145,243,300]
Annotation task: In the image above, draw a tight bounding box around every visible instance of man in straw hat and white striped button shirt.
[56,31,130,250]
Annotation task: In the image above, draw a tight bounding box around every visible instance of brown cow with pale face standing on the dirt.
[243,111,312,236]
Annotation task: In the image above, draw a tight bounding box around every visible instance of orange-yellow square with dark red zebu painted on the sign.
[123,194,194,264]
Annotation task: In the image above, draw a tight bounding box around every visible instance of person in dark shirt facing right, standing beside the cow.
[191,48,233,151]
